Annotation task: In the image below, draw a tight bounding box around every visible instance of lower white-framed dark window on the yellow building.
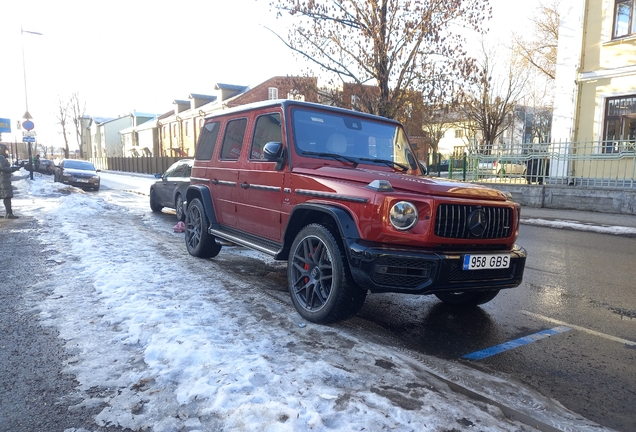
[602,95,636,153]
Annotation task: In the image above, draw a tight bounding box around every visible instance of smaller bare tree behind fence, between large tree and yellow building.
[462,42,527,154]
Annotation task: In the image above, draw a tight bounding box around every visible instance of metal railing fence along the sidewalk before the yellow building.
[429,141,636,188]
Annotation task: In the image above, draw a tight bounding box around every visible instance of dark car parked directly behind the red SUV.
[150,159,194,221]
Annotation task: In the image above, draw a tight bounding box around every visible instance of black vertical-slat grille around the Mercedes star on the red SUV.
[435,204,512,239]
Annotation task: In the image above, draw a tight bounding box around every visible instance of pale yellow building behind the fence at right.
[552,0,636,178]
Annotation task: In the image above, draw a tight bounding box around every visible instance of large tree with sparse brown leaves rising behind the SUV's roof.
[270,0,491,118]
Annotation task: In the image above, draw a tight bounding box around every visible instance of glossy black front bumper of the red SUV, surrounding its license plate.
[348,242,526,294]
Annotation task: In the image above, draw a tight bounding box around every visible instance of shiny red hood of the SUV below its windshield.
[294,166,507,201]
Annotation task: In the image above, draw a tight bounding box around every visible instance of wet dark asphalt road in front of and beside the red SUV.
[360,225,636,432]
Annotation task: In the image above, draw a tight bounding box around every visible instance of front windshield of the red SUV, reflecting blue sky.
[292,108,417,171]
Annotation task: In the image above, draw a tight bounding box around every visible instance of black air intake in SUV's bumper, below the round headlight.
[371,256,433,288]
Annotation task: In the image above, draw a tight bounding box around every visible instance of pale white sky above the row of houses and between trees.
[0,0,537,154]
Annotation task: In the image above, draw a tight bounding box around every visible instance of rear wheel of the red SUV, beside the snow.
[185,198,221,258]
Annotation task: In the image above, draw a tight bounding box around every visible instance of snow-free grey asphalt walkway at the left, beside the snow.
[0,218,121,432]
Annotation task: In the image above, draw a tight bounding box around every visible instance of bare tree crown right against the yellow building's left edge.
[513,0,561,80]
